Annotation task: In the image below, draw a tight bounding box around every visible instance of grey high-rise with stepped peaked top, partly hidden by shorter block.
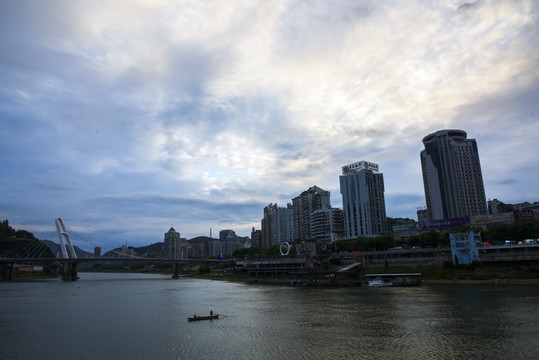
[292,186,331,243]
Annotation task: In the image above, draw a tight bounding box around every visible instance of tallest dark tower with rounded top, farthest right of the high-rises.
[421,130,487,220]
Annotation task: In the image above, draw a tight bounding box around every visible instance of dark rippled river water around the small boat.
[0,273,539,360]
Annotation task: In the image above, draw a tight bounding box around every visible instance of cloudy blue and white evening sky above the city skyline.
[0,0,539,251]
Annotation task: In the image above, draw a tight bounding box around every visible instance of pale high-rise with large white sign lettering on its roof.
[339,161,388,238]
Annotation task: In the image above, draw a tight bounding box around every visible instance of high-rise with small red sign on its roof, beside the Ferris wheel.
[261,204,292,247]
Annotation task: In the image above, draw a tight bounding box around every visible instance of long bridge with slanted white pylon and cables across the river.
[0,218,234,281]
